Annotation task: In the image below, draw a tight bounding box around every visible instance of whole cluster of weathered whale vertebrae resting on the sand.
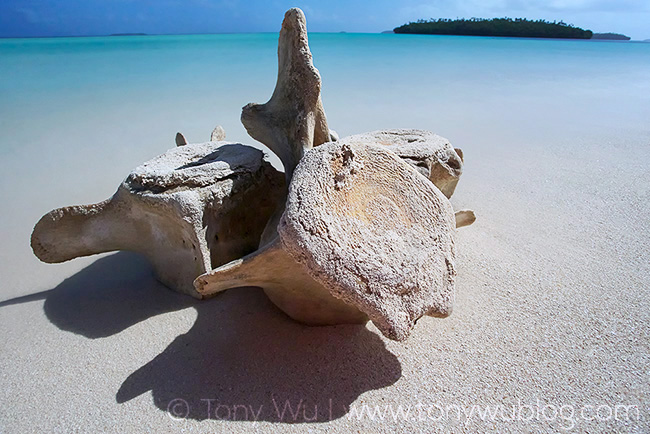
[32,9,476,340]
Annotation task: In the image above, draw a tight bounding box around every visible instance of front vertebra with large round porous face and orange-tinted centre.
[195,143,456,340]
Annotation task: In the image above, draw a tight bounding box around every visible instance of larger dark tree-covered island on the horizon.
[394,18,593,39]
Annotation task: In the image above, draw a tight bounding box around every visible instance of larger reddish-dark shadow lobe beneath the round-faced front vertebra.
[116,288,401,423]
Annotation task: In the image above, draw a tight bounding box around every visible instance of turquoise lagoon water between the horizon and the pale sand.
[0,34,650,154]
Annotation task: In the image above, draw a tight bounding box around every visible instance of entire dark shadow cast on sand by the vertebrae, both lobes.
[0,252,402,423]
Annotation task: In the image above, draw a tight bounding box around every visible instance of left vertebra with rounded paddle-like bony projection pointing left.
[31,142,285,298]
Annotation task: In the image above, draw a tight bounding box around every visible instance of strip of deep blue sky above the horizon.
[0,0,650,39]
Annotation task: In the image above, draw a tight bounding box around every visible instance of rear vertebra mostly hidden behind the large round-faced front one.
[341,129,463,197]
